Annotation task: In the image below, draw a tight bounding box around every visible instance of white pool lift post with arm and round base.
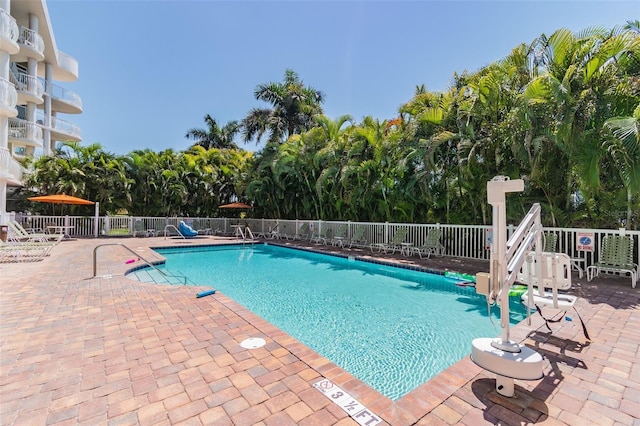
[471,176,543,397]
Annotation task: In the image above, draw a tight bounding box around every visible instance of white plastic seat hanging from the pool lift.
[517,252,591,340]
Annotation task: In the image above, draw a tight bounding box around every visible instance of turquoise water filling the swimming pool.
[130,245,525,400]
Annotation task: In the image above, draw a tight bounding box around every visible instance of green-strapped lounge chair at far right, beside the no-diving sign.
[587,235,638,288]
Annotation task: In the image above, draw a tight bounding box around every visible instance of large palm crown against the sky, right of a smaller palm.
[242,69,324,143]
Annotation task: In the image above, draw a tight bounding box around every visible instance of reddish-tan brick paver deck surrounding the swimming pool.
[0,237,640,426]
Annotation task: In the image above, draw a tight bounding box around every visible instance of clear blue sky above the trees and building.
[47,0,640,154]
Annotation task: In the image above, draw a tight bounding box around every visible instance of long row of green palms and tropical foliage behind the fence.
[15,21,640,229]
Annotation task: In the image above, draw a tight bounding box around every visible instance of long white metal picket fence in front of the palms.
[10,214,640,267]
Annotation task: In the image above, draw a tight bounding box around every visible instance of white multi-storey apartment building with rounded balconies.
[0,0,82,225]
